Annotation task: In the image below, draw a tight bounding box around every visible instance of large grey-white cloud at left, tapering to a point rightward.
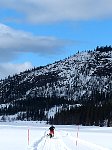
[0,24,67,61]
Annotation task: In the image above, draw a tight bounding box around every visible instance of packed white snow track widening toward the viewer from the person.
[28,131,110,150]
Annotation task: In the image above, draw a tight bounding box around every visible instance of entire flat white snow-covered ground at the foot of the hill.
[0,122,112,150]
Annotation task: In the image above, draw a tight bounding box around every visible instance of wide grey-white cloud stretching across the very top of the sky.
[0,0,112,23]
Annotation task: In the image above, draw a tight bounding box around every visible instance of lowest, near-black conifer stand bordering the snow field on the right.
[49,103,112,126]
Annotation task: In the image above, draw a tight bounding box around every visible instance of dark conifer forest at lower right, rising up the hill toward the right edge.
[49,91,112,126]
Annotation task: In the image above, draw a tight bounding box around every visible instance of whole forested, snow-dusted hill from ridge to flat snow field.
[0,46,112,125]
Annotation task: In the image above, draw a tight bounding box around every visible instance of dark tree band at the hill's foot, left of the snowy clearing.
[0,96,74,121]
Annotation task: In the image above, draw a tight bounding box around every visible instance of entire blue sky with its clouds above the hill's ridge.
[0,0,112,79]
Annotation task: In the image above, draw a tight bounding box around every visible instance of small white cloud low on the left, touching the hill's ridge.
[0,62,33,79]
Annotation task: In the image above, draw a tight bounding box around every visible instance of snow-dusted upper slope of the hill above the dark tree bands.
[0,46,112,120]
